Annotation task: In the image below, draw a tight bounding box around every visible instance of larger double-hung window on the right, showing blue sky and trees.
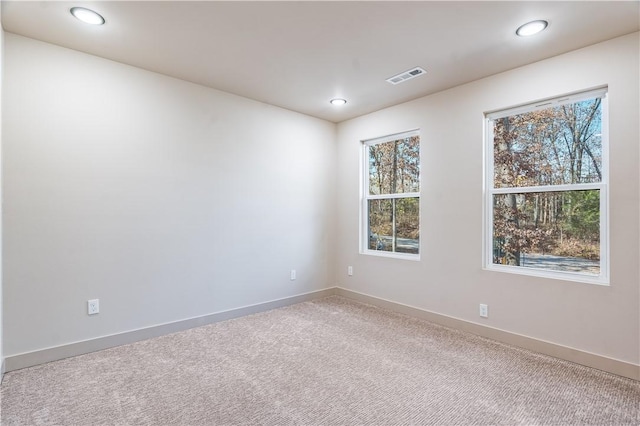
[484,89,608,284]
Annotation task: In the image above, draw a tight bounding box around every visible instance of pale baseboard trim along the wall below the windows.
[335,287,640,380]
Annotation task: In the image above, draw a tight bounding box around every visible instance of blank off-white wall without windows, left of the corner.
[3,33,336,356]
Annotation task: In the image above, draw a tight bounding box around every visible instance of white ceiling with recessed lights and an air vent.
[2,0,640,122]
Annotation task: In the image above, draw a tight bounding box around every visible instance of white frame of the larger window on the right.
[483,87,610,285]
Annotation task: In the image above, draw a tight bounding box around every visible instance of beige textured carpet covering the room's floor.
[1,297,640,425]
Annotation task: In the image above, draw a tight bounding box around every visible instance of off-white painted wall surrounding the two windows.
[337,33,640,364]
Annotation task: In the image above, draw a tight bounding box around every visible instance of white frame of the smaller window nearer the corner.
[360,129,422,261]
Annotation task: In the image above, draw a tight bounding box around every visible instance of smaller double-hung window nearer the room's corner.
[362,131,420,259]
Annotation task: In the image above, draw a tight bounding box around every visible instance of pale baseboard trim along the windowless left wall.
[2,287,336,372]
